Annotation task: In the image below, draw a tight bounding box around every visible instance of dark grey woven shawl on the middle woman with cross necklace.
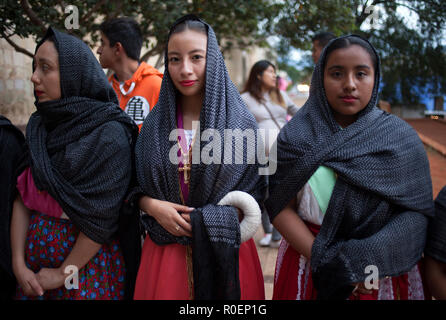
[135,16,265,299]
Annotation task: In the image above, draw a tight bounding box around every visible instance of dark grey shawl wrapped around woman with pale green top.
[265,35,433,299]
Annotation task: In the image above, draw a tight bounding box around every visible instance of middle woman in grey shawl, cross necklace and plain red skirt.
[134,15,265,299]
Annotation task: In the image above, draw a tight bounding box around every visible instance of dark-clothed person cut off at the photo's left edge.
[0,115,25,301]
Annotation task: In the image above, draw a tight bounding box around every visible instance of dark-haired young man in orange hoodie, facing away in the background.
[97,17,163,129]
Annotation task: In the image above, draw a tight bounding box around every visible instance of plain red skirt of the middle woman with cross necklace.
[134,236,265,300]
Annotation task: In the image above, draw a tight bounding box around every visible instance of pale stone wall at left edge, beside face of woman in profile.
[0,36,36,127]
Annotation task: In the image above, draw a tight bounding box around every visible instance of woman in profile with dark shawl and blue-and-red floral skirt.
[11,28,137,299]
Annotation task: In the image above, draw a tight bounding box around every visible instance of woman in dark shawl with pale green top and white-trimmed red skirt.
[266,35,433,299]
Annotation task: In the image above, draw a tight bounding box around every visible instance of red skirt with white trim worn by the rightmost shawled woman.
[273,222,430,300]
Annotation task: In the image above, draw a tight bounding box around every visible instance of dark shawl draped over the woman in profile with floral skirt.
[26,28,137,243]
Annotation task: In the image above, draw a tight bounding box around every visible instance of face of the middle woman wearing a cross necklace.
[167,30,207,96]
